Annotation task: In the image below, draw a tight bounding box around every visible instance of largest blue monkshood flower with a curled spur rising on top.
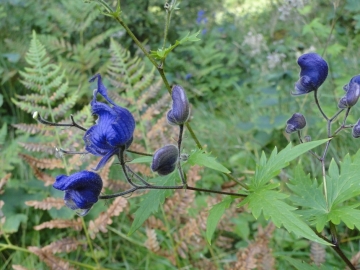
[83,74,135,170]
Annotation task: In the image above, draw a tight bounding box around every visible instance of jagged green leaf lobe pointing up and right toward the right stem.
[250,139,329,190]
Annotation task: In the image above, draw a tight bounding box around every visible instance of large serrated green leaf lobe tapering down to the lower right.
[240,189,329,245]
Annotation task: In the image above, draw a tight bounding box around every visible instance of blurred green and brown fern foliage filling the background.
[0,0,360,269]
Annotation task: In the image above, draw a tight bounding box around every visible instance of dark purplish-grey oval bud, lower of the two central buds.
[151,144,179,175]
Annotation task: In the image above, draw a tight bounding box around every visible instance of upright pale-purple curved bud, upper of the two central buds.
[166,85,190,125]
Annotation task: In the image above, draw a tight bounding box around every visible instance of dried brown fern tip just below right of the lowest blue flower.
[88,197,128,239]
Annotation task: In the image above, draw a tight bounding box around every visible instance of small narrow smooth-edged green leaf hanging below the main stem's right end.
[206,197,233,245]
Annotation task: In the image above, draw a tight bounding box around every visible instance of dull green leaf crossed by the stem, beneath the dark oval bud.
[128,171,177,235]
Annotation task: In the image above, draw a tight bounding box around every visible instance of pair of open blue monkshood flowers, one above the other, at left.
[53,74,135,216]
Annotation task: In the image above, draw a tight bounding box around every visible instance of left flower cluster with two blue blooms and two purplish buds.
[52,74,190,216]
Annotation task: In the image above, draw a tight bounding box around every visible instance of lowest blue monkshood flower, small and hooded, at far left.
[53,171,103,216]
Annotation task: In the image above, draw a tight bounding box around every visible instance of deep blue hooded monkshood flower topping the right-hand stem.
[291,53,329,96]
